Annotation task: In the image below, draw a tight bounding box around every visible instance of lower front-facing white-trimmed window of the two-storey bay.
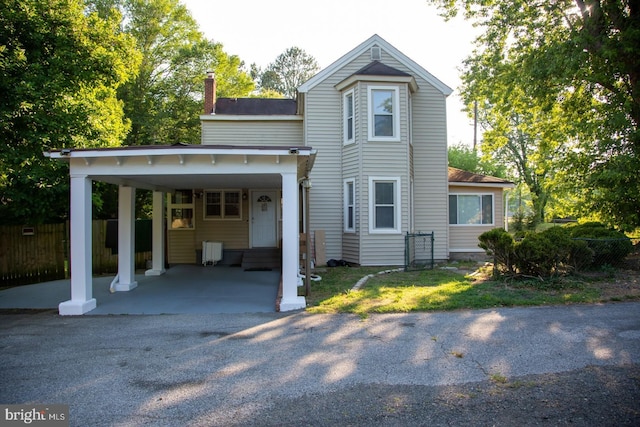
[369,177,400,233]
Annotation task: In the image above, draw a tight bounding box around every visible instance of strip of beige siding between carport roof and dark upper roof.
[202,120,303,146]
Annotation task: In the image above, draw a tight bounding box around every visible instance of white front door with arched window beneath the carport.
[251,191,280,248]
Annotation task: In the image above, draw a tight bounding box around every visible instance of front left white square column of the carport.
[58,175,96,316]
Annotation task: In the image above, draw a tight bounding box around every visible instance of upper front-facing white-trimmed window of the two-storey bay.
[368,86,400,141]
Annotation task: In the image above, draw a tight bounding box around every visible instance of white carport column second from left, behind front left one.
[114,185,138,291]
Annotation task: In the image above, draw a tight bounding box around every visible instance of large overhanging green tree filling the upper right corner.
[429,0,640,228]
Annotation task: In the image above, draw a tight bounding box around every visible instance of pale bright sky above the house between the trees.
[182,0,476,146]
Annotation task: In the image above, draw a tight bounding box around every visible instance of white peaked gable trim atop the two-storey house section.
[298,34,453,96]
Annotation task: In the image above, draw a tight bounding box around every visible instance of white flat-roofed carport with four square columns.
[44,144,316,315]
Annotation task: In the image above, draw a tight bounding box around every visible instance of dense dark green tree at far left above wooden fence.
[0,0,139,224]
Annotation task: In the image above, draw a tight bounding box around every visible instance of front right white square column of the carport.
[280,173,307,311]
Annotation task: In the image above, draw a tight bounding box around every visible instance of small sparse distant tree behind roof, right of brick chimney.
[254,46,320,99]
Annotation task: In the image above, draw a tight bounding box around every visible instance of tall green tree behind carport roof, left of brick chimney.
[115,0,254,145]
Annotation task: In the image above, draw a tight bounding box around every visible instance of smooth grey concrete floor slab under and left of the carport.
[0,265,281,315]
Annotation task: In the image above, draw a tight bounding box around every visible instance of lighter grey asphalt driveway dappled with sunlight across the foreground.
[0,303,640,426]
